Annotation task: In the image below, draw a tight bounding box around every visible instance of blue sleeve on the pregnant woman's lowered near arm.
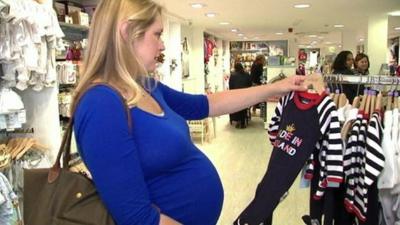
[74,86,160,225]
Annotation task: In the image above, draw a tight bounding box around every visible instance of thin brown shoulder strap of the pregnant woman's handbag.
[47,82,132,183]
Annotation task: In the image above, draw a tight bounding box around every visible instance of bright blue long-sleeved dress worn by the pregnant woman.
[74,83,223,225]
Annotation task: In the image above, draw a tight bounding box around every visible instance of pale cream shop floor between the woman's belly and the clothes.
[196,105,309,225]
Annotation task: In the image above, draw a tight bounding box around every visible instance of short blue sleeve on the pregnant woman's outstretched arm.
[157,82,209,120]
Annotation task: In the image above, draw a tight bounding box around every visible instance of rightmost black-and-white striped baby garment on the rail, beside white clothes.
[344,111,385,223]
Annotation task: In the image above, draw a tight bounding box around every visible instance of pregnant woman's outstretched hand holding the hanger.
[270,75,307,96]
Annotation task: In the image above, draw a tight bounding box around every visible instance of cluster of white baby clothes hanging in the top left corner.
[0,0,64,91]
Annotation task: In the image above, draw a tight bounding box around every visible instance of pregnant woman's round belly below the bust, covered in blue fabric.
[148,151,224,225]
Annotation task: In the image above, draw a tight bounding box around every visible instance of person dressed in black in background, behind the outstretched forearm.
[229,62,251,129]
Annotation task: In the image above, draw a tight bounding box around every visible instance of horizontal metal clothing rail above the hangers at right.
[323,74,400,85]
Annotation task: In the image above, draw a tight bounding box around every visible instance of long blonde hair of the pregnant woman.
[72,0,162,112]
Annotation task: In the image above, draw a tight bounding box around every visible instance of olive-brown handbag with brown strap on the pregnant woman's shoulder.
[23,85,130,225]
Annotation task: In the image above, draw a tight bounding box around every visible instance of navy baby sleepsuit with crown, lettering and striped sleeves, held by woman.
[236,92,343,225]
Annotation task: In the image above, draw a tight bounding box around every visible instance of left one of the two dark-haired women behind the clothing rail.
[332,51,364,103]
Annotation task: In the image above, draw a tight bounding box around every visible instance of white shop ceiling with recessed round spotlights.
[156,0,400,44]
